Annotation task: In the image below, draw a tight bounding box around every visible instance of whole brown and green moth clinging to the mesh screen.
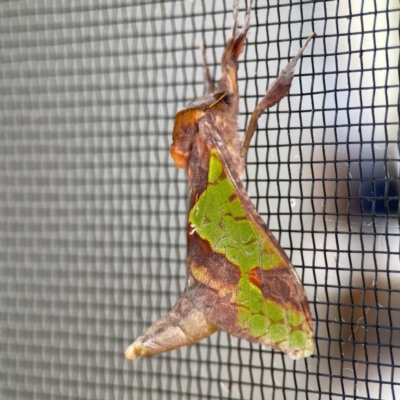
[125,1,316,359]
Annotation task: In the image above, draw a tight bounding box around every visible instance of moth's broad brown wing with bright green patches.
[186,148,314,359]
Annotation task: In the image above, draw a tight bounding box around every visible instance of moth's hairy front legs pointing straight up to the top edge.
[218,0,253,94]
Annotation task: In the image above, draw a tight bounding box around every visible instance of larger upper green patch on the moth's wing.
[189,150,285,272]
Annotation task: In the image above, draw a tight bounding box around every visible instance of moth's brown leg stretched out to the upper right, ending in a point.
[240,33,317,158]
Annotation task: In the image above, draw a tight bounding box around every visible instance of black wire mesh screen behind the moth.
[0,0,400,400]
